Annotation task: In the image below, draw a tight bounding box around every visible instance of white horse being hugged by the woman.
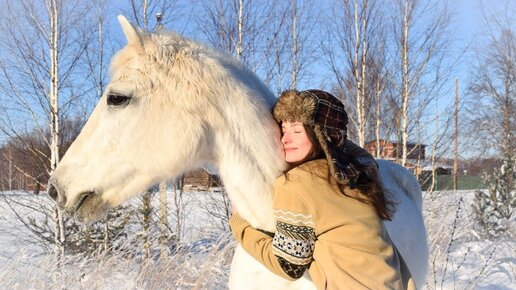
[48,16,428,290]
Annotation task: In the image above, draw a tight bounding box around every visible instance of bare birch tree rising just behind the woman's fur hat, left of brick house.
[325,0,386,146]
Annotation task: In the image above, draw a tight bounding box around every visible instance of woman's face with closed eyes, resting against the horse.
[281,122,313,163]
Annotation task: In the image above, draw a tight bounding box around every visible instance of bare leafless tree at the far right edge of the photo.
[466,15,516,163]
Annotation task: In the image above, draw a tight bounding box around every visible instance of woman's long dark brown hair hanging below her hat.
[285,124,395,220]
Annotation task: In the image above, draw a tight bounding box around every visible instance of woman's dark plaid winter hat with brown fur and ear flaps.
[273,90,364,184]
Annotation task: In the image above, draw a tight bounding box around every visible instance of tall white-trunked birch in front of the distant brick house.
[393,0,452,165]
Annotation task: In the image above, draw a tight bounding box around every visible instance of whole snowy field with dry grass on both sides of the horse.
[0,191,516,289]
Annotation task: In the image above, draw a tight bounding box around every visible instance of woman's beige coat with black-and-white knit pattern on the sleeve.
[230,160,408,290]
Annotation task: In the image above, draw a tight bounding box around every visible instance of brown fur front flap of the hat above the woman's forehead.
[273,90,317,125]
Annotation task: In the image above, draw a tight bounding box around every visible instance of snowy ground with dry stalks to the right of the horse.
[424,191,516,289]
